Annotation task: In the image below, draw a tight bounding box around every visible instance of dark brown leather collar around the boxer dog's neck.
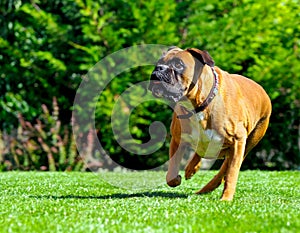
[177,66,219,119]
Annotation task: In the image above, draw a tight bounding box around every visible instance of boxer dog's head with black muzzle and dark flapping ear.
[149,47,214,102]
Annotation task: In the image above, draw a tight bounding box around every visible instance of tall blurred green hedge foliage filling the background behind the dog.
[0,0,300,169]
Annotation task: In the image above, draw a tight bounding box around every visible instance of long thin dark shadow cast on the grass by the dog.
[30,192,188,200]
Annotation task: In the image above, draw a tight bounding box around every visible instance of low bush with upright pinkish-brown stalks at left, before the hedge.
[0,98,94,171]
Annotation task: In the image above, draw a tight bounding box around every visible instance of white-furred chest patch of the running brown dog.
[181,113,224,159]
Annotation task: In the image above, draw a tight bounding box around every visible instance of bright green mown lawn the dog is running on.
[0,171,300,233]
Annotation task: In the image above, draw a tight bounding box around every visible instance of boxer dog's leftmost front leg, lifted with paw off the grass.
[166,139,185,187]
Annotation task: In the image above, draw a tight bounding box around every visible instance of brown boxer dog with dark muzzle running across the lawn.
[149,47,271,200]
